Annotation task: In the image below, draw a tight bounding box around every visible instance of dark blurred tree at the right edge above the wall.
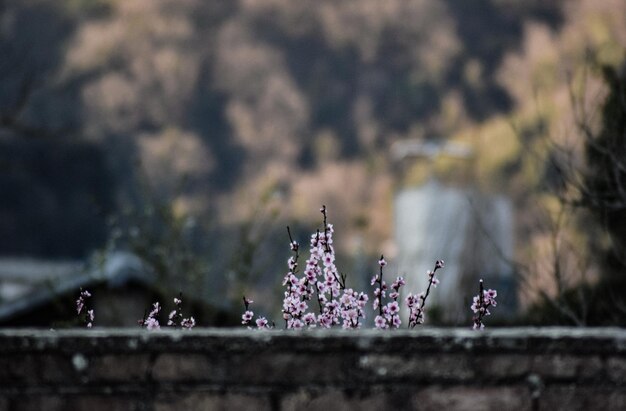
[529,64,626,326]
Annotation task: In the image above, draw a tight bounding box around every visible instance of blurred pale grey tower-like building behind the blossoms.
[394,142,517,325]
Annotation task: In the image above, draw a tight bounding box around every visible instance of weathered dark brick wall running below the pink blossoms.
[0,328,626,411]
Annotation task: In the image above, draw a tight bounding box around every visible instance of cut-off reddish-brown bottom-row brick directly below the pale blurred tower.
[411,386,531,411]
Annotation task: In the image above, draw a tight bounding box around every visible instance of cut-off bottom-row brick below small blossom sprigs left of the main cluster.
[154,393,272,411]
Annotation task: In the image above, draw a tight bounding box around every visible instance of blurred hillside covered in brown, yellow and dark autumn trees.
[0,0,626,322]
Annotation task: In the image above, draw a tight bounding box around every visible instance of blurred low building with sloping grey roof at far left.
[0,252,229,328]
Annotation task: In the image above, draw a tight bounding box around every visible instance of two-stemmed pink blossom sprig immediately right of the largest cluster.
[371,255,406,329]
